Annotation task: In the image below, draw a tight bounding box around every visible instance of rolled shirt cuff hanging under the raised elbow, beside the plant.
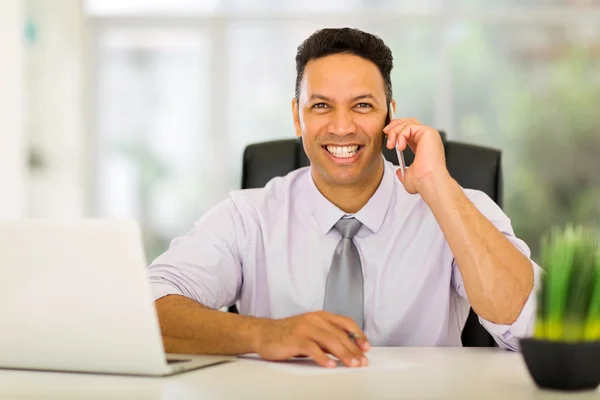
[479,261,542,351]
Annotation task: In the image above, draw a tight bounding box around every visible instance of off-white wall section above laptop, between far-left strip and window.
[25,0,87,218]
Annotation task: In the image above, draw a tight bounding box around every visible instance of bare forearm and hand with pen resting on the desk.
[156,295,368,367]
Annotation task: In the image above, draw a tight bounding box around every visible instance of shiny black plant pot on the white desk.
[520,339,600,390]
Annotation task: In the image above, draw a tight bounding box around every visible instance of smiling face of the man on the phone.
[292,54,387,185]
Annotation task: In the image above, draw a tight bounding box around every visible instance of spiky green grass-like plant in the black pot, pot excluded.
[534,226,600,342]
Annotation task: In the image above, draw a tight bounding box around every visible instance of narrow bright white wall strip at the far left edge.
[0,0,25,219]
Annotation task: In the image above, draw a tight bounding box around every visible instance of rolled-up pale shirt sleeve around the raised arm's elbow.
[452,191,543,351]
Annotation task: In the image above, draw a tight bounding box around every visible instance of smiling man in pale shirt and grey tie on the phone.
[149,28,540,367]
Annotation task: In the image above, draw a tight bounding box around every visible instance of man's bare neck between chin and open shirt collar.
[311,159,384,214]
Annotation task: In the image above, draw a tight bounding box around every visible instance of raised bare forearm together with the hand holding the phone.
[384,115,534,324]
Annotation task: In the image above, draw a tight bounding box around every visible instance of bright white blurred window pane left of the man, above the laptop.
[96,29,213,257]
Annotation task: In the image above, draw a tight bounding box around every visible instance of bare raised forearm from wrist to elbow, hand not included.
[420,174,534,325]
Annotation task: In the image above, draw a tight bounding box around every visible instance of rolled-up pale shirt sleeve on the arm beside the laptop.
[148,198,244,309]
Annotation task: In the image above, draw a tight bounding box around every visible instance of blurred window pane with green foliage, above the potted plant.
[452,24,600,250]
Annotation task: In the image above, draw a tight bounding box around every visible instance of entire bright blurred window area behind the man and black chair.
[85,0,600,258]
